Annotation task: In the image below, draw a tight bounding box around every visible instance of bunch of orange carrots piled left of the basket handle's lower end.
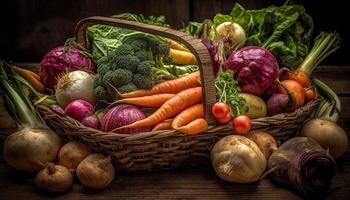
[115,72,208,135]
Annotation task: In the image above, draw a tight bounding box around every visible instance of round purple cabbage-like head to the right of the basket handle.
[224,46,278,96]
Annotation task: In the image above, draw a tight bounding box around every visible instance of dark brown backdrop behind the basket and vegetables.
[0,0,350,65]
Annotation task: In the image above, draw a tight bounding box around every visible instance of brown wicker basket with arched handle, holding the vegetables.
[38,17,319,172]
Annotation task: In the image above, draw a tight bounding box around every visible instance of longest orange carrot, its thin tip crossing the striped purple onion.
[112,87,202,132]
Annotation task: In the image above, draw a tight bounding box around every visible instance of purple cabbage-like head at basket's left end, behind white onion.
[39,46,96,90]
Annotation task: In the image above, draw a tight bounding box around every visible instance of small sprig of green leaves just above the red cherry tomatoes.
[215,70,248,116]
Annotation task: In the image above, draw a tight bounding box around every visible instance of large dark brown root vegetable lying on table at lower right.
[268,137,336,196]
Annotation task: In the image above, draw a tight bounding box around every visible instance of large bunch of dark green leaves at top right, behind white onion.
[213,1,314,69]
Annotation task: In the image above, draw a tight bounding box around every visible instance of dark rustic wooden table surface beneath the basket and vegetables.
[0,66,350,200]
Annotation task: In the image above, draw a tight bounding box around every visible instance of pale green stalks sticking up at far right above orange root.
[298,32,340,77]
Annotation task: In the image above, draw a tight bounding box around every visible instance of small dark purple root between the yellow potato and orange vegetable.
[266,94,295,116]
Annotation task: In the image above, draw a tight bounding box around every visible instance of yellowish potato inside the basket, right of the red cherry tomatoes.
[239,93,267,119]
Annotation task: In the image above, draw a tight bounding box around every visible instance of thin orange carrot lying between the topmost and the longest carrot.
[112,93,175,108]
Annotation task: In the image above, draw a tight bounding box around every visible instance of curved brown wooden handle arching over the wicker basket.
[75,16,216,124]
